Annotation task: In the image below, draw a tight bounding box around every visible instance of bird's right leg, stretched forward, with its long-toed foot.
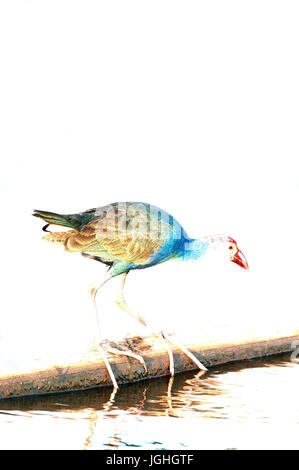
[116,273,207,376]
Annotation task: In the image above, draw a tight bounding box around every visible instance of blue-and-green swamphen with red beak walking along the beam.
[32,201,248,389]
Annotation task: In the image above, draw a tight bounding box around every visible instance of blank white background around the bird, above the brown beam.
[0,0,299,369]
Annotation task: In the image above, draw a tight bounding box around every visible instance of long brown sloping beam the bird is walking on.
[0,331,299,399]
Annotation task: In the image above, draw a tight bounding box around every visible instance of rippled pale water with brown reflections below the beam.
[0,353,299,450]
